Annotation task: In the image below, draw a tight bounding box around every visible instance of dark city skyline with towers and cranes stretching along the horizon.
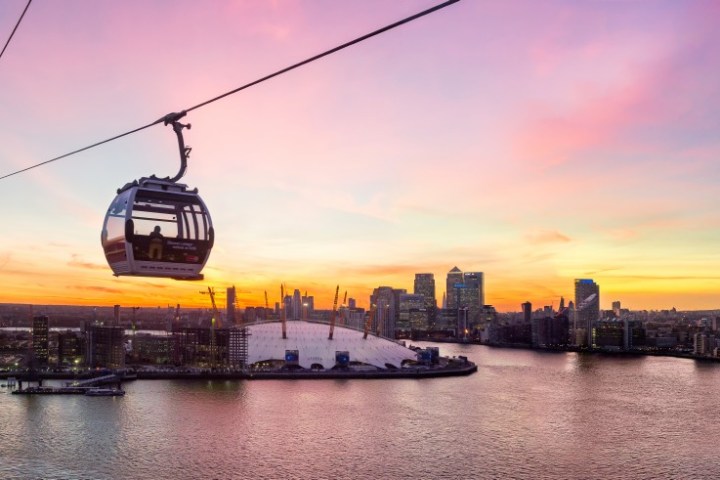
[0,267,720,368]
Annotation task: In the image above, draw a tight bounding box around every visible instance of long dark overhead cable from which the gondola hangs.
[0,0,460,180]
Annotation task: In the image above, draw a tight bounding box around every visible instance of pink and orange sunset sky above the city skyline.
[0,0,720,311]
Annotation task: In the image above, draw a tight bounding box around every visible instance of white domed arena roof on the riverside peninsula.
[246,320,417,370]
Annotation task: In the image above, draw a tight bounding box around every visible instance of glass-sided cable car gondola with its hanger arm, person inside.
[101,111,215,280]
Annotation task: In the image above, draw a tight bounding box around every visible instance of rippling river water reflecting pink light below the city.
[0,344,720,479]
